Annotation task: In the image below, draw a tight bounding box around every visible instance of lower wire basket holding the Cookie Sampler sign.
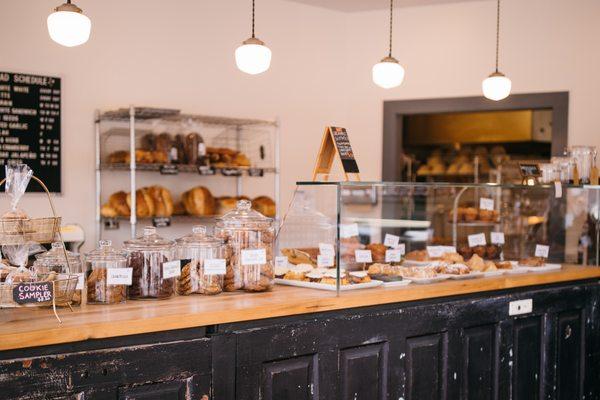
[0,273,79,308]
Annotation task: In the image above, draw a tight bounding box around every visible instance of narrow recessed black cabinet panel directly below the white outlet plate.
[509,316,543,400]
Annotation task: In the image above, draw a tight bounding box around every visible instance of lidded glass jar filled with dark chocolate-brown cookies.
[123,226,180,299]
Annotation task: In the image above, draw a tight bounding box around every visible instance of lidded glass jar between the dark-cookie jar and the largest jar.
[175,225,229,295]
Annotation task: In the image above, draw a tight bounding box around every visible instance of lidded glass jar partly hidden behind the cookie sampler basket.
[32,242,85,305]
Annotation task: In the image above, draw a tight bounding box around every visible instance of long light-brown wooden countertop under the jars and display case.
[0,265,600,350]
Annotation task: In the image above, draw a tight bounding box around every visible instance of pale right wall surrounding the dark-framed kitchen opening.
[345,0,600,178]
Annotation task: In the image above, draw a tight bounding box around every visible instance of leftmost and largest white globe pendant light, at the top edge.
[48,0,92,47]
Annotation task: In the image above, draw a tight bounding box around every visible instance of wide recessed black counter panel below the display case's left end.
[260,354,319,400]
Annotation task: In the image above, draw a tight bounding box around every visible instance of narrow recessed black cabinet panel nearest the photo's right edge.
[556,310,585,400]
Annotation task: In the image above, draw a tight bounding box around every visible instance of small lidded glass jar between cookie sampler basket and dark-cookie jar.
[85,240,131,304]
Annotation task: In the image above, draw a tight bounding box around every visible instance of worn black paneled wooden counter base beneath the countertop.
[0,279,600,400]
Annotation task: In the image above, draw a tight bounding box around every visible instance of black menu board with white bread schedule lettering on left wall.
[0,72,61,192]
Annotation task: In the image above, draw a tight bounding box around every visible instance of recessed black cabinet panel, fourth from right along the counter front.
[405,332,448,400]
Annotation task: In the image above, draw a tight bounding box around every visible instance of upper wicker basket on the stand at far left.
[0,217,61,245]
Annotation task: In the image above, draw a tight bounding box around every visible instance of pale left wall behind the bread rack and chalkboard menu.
[0,0,345,242]
